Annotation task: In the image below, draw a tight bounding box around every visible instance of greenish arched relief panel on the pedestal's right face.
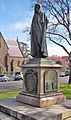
[44,70,57,93]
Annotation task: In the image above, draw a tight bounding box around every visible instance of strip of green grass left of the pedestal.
[0,89,21,98]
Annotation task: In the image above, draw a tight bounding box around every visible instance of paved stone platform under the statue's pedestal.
[0,98,71,120]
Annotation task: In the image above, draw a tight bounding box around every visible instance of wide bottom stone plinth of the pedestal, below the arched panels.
[16,93,66,107]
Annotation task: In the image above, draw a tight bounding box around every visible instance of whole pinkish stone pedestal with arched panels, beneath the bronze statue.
[16,58,65,107]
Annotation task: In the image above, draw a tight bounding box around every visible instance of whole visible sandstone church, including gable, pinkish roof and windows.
[0,32,24,73]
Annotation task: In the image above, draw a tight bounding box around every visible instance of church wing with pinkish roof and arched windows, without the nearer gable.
[6,40,24,71]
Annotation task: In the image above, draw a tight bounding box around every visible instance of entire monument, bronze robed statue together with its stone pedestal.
[16,4,65,107]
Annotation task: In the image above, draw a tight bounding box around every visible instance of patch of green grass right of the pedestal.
[60,84,71,98]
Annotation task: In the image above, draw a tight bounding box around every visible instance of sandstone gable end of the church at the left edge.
[0,32,9,73]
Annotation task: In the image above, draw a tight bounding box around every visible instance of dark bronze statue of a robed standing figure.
[31,4,48,58]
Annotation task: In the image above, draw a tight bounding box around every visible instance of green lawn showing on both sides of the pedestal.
[0,84,71,98]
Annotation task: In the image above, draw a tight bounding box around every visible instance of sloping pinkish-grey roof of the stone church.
[6,40,23,57]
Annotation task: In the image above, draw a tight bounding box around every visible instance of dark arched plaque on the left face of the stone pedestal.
[24,69,38,94]
